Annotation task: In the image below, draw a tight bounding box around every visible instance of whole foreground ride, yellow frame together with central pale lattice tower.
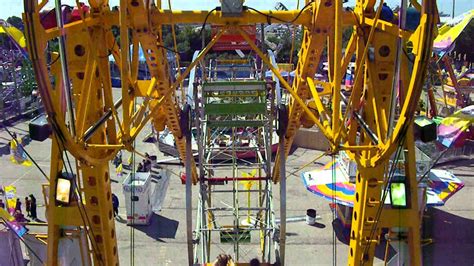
[24,0,437,265]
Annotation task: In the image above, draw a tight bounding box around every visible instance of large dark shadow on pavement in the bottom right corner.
[423,208,474,265]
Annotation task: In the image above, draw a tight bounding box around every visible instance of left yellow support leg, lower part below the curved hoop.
[47,136,118,265]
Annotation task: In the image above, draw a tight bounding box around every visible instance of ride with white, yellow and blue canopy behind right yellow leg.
[301,148,464,224]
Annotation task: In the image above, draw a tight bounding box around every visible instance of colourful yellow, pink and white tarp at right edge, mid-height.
[438,105,474,148]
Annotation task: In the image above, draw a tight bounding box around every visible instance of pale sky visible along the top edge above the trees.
[0,0,474,19]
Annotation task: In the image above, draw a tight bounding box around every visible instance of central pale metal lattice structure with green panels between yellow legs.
[189,77,280,263]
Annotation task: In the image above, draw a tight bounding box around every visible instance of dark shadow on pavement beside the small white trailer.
[133,213,179,242]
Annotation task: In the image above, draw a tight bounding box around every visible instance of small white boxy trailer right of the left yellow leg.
[122,172,153,225]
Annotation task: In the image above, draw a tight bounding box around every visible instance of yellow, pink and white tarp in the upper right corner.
[433,9,474,53]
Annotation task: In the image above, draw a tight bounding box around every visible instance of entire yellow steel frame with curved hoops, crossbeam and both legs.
[24,0,437,265]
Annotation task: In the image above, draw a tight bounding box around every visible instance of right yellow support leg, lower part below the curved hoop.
[348,125,421,265]
